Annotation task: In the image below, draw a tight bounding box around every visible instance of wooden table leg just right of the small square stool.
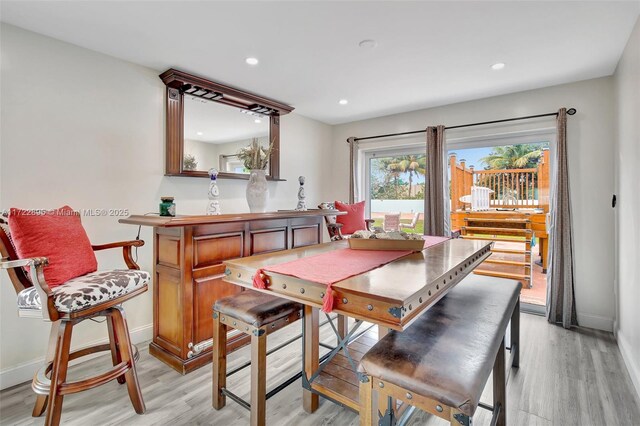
[302,305,320,413]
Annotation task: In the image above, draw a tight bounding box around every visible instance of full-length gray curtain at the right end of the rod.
[547,108,578,328]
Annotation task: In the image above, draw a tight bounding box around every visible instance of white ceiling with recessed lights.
[0,0,640,124]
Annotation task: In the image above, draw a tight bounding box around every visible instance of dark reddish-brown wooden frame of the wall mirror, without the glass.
[160,68,293,180]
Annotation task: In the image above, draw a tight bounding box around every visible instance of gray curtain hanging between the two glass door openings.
[424,126,449,236]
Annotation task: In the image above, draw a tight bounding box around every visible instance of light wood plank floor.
[0,314,640,426]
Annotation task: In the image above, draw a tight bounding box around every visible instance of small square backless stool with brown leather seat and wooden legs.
[213,290,303,426]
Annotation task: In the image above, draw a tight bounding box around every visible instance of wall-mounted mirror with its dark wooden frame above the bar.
[160,69,293,180]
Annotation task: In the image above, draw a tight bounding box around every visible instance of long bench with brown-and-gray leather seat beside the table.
[359,275,522,426]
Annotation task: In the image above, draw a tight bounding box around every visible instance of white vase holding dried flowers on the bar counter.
[238,138,273,213]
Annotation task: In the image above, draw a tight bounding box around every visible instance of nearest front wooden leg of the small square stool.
[251,333,267,426]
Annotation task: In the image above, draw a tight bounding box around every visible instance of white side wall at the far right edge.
[614,20,640,400]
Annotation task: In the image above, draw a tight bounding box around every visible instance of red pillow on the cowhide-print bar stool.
[9,206,98,287]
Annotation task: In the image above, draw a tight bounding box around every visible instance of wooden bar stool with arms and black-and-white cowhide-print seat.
[0,208,151,425]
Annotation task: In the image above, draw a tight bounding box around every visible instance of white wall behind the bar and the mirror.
[0,24,333,388]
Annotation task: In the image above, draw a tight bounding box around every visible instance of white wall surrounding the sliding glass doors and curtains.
[331,77,616,330]
